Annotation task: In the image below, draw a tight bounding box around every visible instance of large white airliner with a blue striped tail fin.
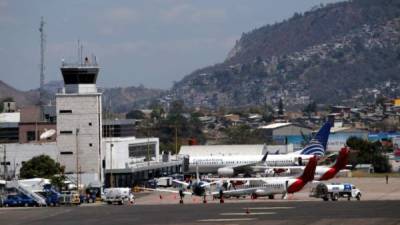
[189,121,332,177]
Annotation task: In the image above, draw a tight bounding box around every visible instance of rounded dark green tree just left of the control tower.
[20,155,64,179]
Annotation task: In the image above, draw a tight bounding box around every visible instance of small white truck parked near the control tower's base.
[104,188,135,205]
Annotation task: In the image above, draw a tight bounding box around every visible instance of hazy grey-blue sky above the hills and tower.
[0,0,338,90]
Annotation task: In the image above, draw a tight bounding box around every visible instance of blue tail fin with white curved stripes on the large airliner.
[300,120,333,156]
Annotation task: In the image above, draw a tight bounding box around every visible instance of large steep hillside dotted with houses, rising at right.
[172,0,400,108]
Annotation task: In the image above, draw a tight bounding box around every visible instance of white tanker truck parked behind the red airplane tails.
[310,183,361,201]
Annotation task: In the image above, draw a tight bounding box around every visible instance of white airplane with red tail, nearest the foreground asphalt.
[213,156,317,203]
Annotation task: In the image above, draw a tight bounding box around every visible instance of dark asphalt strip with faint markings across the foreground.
[0,201,400,225]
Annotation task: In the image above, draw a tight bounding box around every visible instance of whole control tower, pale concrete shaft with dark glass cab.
[56,58,103,185]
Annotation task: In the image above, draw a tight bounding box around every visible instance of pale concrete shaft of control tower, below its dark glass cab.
[56,93,102,183]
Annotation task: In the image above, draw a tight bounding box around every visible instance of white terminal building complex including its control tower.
[0,58,182,187]
